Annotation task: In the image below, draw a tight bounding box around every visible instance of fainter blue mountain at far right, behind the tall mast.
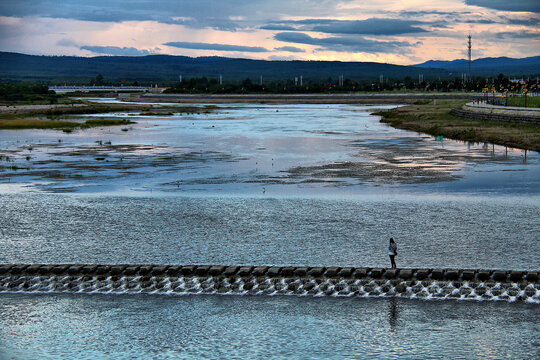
[414,56,540,76]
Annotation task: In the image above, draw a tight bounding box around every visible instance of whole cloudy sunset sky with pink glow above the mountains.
[0,0,540,64]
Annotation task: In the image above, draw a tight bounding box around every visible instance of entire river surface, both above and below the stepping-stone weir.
[0,105,540,359]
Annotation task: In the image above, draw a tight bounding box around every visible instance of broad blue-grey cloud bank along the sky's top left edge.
[0,0,337,30]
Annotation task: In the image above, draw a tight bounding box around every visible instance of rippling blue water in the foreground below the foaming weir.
[0,295,540,359]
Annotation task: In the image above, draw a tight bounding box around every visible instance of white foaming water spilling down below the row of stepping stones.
[0,275,540,304]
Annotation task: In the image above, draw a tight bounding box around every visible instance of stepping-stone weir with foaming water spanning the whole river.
[0,264,540,304]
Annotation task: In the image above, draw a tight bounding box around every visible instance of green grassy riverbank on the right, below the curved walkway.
[376,100,540,151]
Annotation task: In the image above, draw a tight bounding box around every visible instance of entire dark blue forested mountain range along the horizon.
[0,52,540,85]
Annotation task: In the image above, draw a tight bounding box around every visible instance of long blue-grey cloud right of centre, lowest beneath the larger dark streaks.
[274,32,412,53]
